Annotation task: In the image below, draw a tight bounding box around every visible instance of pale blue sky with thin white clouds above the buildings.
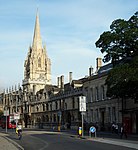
[0,0,138,90]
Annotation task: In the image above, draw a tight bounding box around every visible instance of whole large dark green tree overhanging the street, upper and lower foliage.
[95,12,138,100]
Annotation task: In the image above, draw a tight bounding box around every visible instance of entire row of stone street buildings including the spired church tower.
[0,12,138,133]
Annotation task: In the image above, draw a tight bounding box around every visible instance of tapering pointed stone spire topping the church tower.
[32,10,42,50]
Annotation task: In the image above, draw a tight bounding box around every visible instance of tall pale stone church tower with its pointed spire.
[23,11,51,92]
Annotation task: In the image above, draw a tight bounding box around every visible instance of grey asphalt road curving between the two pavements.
[5,131,134,150]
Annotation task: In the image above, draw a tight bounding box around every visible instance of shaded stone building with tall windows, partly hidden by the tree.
[83,61,138,133]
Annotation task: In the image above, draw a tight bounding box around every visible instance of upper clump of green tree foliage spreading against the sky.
[95,12,138,64]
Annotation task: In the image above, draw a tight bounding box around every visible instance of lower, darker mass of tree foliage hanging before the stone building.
[106,56,138,99]
